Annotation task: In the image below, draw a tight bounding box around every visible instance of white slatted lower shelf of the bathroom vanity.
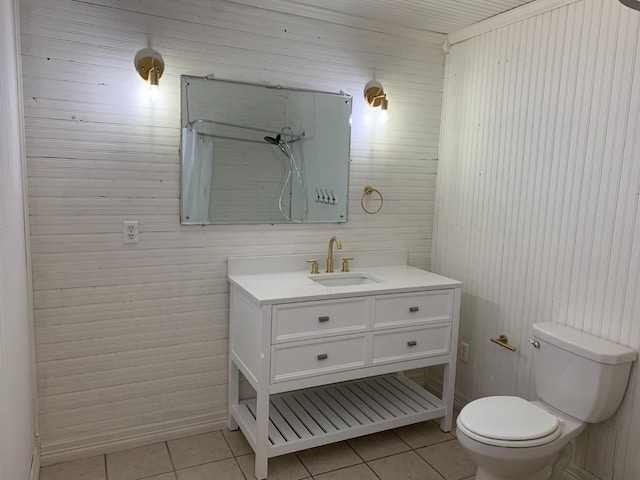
[234,374,446,457]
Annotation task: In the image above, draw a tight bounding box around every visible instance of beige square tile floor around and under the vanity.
[40,421,475,480]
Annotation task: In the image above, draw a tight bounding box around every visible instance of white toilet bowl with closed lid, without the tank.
[456,397,587,480]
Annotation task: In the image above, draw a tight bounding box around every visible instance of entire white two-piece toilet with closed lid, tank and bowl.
[457,322,636,480]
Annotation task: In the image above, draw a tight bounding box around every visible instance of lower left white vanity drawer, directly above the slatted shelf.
[271,333,368,382]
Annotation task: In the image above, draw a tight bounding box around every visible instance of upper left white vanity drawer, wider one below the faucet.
[271,297,371,344]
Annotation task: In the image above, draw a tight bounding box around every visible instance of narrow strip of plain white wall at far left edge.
[0,0,37,480]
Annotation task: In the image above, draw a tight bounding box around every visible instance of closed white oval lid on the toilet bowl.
[458,397,560,441]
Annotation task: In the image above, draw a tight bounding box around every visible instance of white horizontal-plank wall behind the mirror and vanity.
[20,0,444,464]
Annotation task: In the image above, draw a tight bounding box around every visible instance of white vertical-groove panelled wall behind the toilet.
[434,0,640,480]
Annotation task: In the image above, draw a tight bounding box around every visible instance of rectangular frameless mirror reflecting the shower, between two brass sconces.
[181,75,352,225]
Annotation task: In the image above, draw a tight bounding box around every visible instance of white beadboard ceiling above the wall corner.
[232,0,532,33]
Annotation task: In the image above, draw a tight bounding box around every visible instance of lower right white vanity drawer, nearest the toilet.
[371,322,451,365]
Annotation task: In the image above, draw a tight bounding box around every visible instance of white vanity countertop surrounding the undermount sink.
[229,265,462,305]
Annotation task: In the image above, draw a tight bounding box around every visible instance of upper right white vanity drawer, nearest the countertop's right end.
[373,289,453,329]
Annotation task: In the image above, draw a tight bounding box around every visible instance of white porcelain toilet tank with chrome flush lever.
[533,322,636,423]
